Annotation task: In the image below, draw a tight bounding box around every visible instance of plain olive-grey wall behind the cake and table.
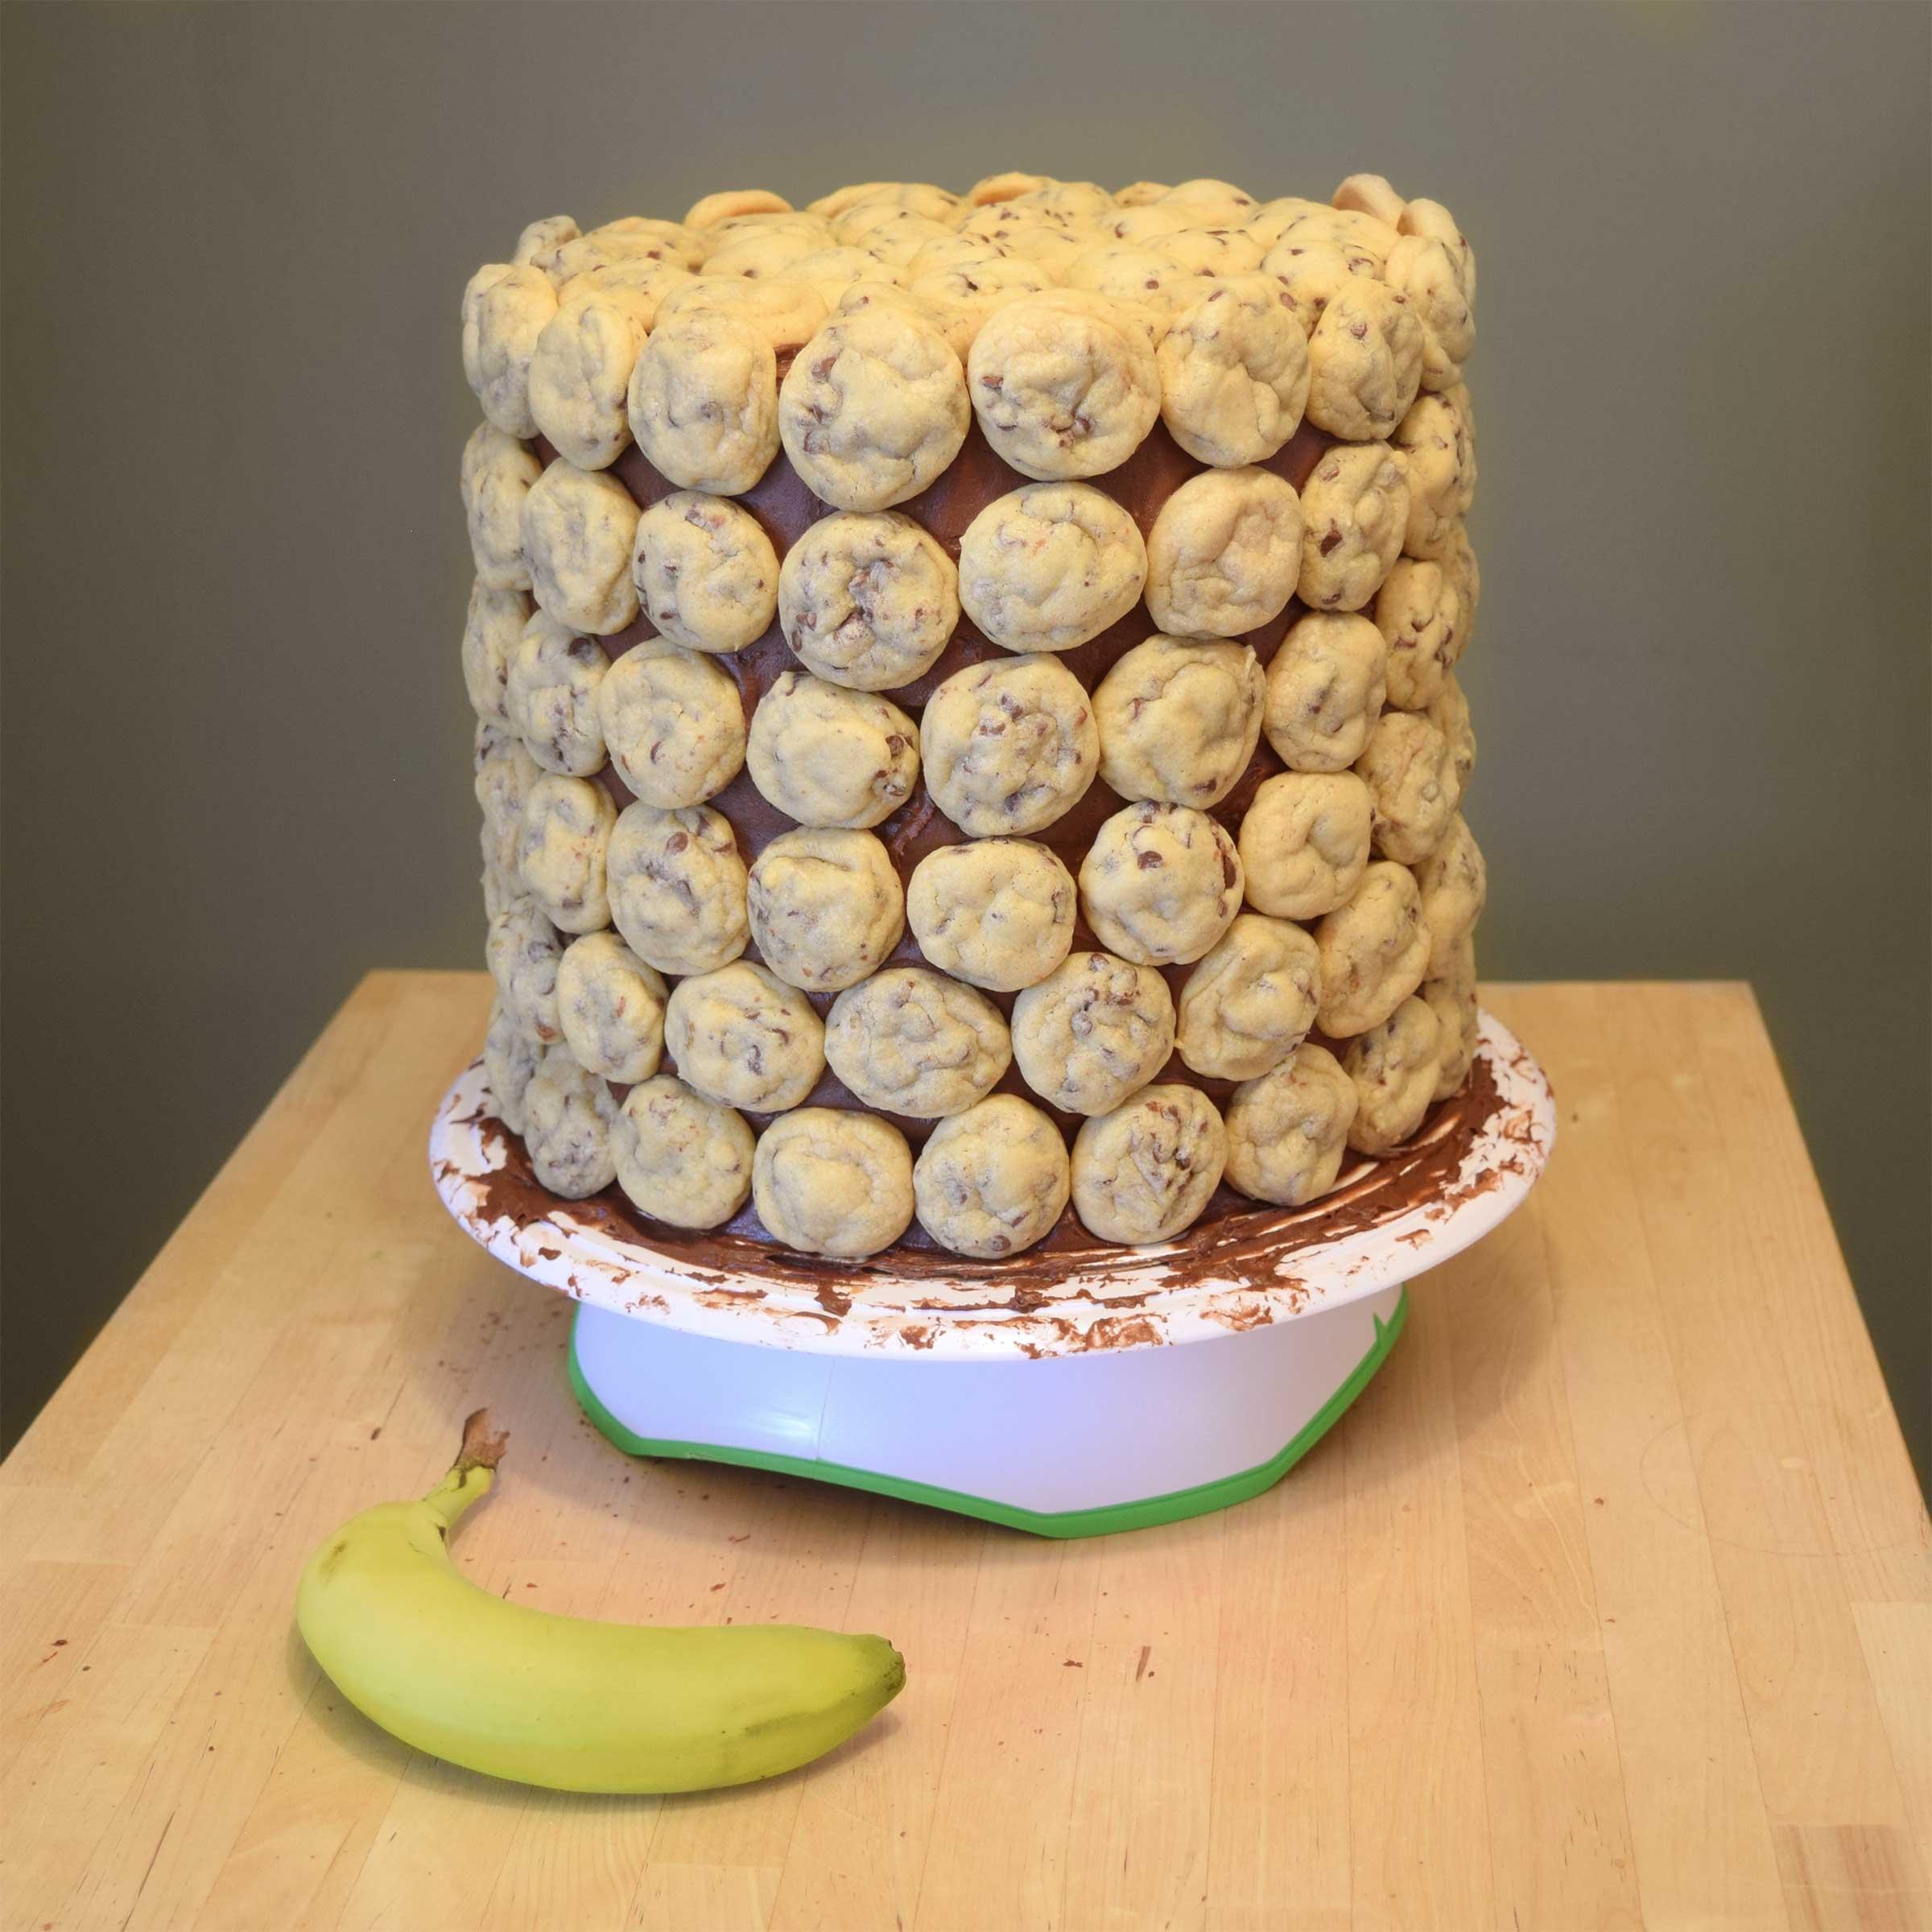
[0,0,1932,1467]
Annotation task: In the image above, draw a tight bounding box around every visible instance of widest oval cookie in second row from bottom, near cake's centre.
[825,966,1013,1121]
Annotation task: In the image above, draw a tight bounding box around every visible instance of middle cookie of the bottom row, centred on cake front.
[912,1093,1072,1261]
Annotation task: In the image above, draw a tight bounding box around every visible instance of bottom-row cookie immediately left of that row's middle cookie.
[752,1107,912,1261]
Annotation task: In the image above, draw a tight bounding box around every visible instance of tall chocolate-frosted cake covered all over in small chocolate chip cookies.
[462,175,1484,1260]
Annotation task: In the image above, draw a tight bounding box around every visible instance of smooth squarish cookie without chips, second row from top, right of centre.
[1148,469,1304,638]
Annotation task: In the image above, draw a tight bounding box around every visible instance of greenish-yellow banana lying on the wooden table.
[295,1410,906,1791]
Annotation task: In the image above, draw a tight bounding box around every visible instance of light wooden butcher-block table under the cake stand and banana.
[0,974,1932,1932]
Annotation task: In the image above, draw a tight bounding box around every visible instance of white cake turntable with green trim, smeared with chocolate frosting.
[429,1013,1555,1536]
